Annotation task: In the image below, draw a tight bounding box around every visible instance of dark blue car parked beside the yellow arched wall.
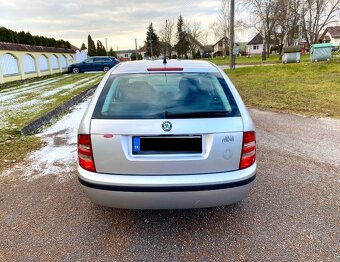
[68,56,119,74]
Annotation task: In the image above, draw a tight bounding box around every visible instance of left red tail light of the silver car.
[78,135,96,172]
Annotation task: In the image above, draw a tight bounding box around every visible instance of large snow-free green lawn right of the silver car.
[226,62,340,118]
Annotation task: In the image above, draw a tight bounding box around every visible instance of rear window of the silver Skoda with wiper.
[93,73,240,119]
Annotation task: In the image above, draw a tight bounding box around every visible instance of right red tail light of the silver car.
[240,131,256,169]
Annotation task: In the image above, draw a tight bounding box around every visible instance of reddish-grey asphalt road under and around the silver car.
[0,110,340,262]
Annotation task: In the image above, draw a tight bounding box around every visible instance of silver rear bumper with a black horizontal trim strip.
[78,163,256,209]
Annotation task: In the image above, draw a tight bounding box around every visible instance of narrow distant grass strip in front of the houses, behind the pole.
[207,55,309,65]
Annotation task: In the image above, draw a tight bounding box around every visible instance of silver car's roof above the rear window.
[111,59,219,74]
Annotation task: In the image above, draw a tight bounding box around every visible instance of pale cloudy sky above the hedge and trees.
[0,0,251,50]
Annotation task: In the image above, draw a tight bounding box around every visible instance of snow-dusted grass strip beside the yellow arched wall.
[0,73,103,173]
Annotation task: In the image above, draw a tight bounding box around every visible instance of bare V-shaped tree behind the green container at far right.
[303,0,340,45]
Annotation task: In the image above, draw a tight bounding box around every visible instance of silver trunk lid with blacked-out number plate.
[91,117,243,175]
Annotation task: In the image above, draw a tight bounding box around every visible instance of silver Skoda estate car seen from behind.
[78,60,256,209]
